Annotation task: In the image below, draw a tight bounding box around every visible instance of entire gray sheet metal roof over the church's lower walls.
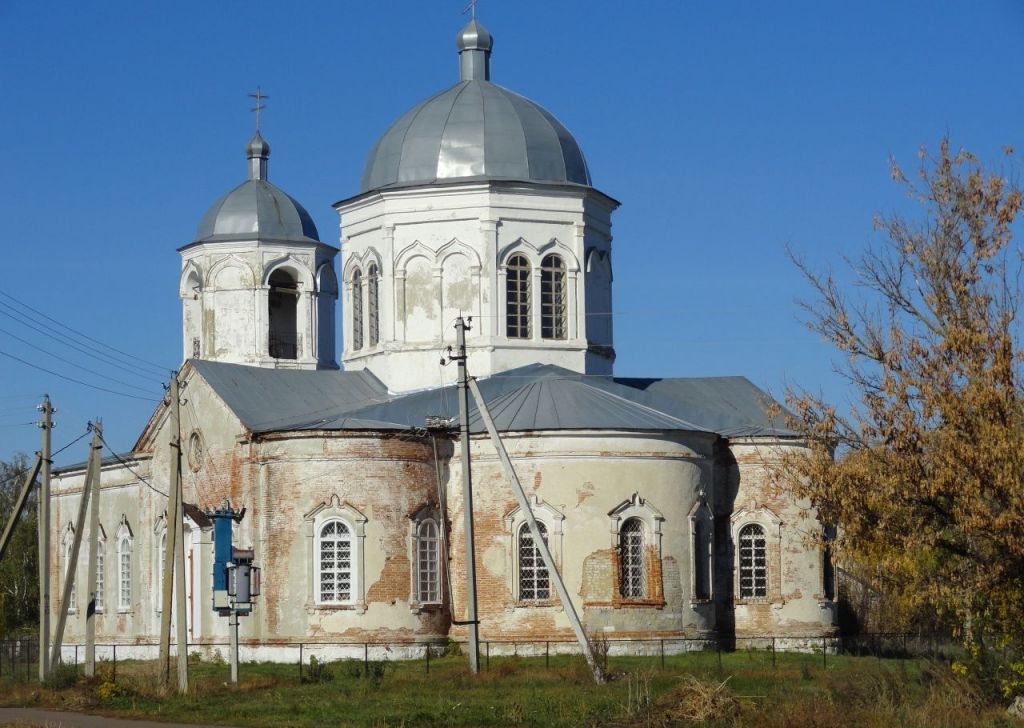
[193,361,795,437]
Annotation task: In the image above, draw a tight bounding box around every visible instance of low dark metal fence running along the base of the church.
[0,633,963,681]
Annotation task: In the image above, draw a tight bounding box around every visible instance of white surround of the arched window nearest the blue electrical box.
[303,495,367,612]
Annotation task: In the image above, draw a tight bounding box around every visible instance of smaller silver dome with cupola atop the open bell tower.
[196,132,319,243]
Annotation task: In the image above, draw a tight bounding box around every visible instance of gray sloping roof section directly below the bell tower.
[191,359,388,432]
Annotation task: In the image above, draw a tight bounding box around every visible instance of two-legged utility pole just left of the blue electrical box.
[160,372,188,693]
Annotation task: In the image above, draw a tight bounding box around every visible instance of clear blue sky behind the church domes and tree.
[0,0,1024,462]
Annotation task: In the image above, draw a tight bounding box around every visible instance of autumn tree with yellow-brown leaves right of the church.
[784,140,1024,679]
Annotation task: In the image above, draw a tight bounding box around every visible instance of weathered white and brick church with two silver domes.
[50,19,835,659]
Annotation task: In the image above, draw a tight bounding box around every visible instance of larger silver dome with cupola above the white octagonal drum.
[359,19,591,192]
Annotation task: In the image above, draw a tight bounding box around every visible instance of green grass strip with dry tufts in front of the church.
[0,651,1013,728]
